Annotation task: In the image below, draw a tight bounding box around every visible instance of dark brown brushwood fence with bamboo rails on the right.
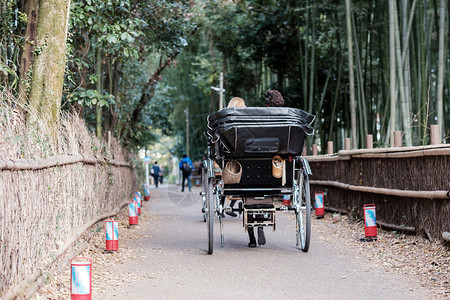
[307,145,450,238]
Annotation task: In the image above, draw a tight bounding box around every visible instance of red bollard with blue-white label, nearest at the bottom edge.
[70,257,92,300]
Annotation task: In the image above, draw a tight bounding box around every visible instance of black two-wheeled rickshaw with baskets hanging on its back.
[201,107,315,254]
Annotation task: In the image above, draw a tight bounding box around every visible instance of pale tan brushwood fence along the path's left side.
[0,99,137,298]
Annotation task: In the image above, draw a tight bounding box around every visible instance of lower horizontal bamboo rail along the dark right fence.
[309,180,450,199]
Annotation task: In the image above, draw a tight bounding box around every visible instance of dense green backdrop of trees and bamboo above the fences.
[0,0,450,158]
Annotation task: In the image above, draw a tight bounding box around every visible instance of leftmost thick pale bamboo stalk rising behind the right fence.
[345,0,358,149]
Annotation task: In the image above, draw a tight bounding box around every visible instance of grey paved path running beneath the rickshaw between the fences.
[94,185,431,299]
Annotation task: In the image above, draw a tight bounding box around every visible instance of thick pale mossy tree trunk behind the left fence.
[27,0,70,136]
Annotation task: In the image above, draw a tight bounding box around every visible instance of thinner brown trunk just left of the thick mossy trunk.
[18,0,39,107]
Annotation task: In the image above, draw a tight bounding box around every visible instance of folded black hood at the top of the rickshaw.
[208,107,315,158]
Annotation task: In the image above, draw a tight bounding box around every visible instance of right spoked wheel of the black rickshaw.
[296,172,311,252]
